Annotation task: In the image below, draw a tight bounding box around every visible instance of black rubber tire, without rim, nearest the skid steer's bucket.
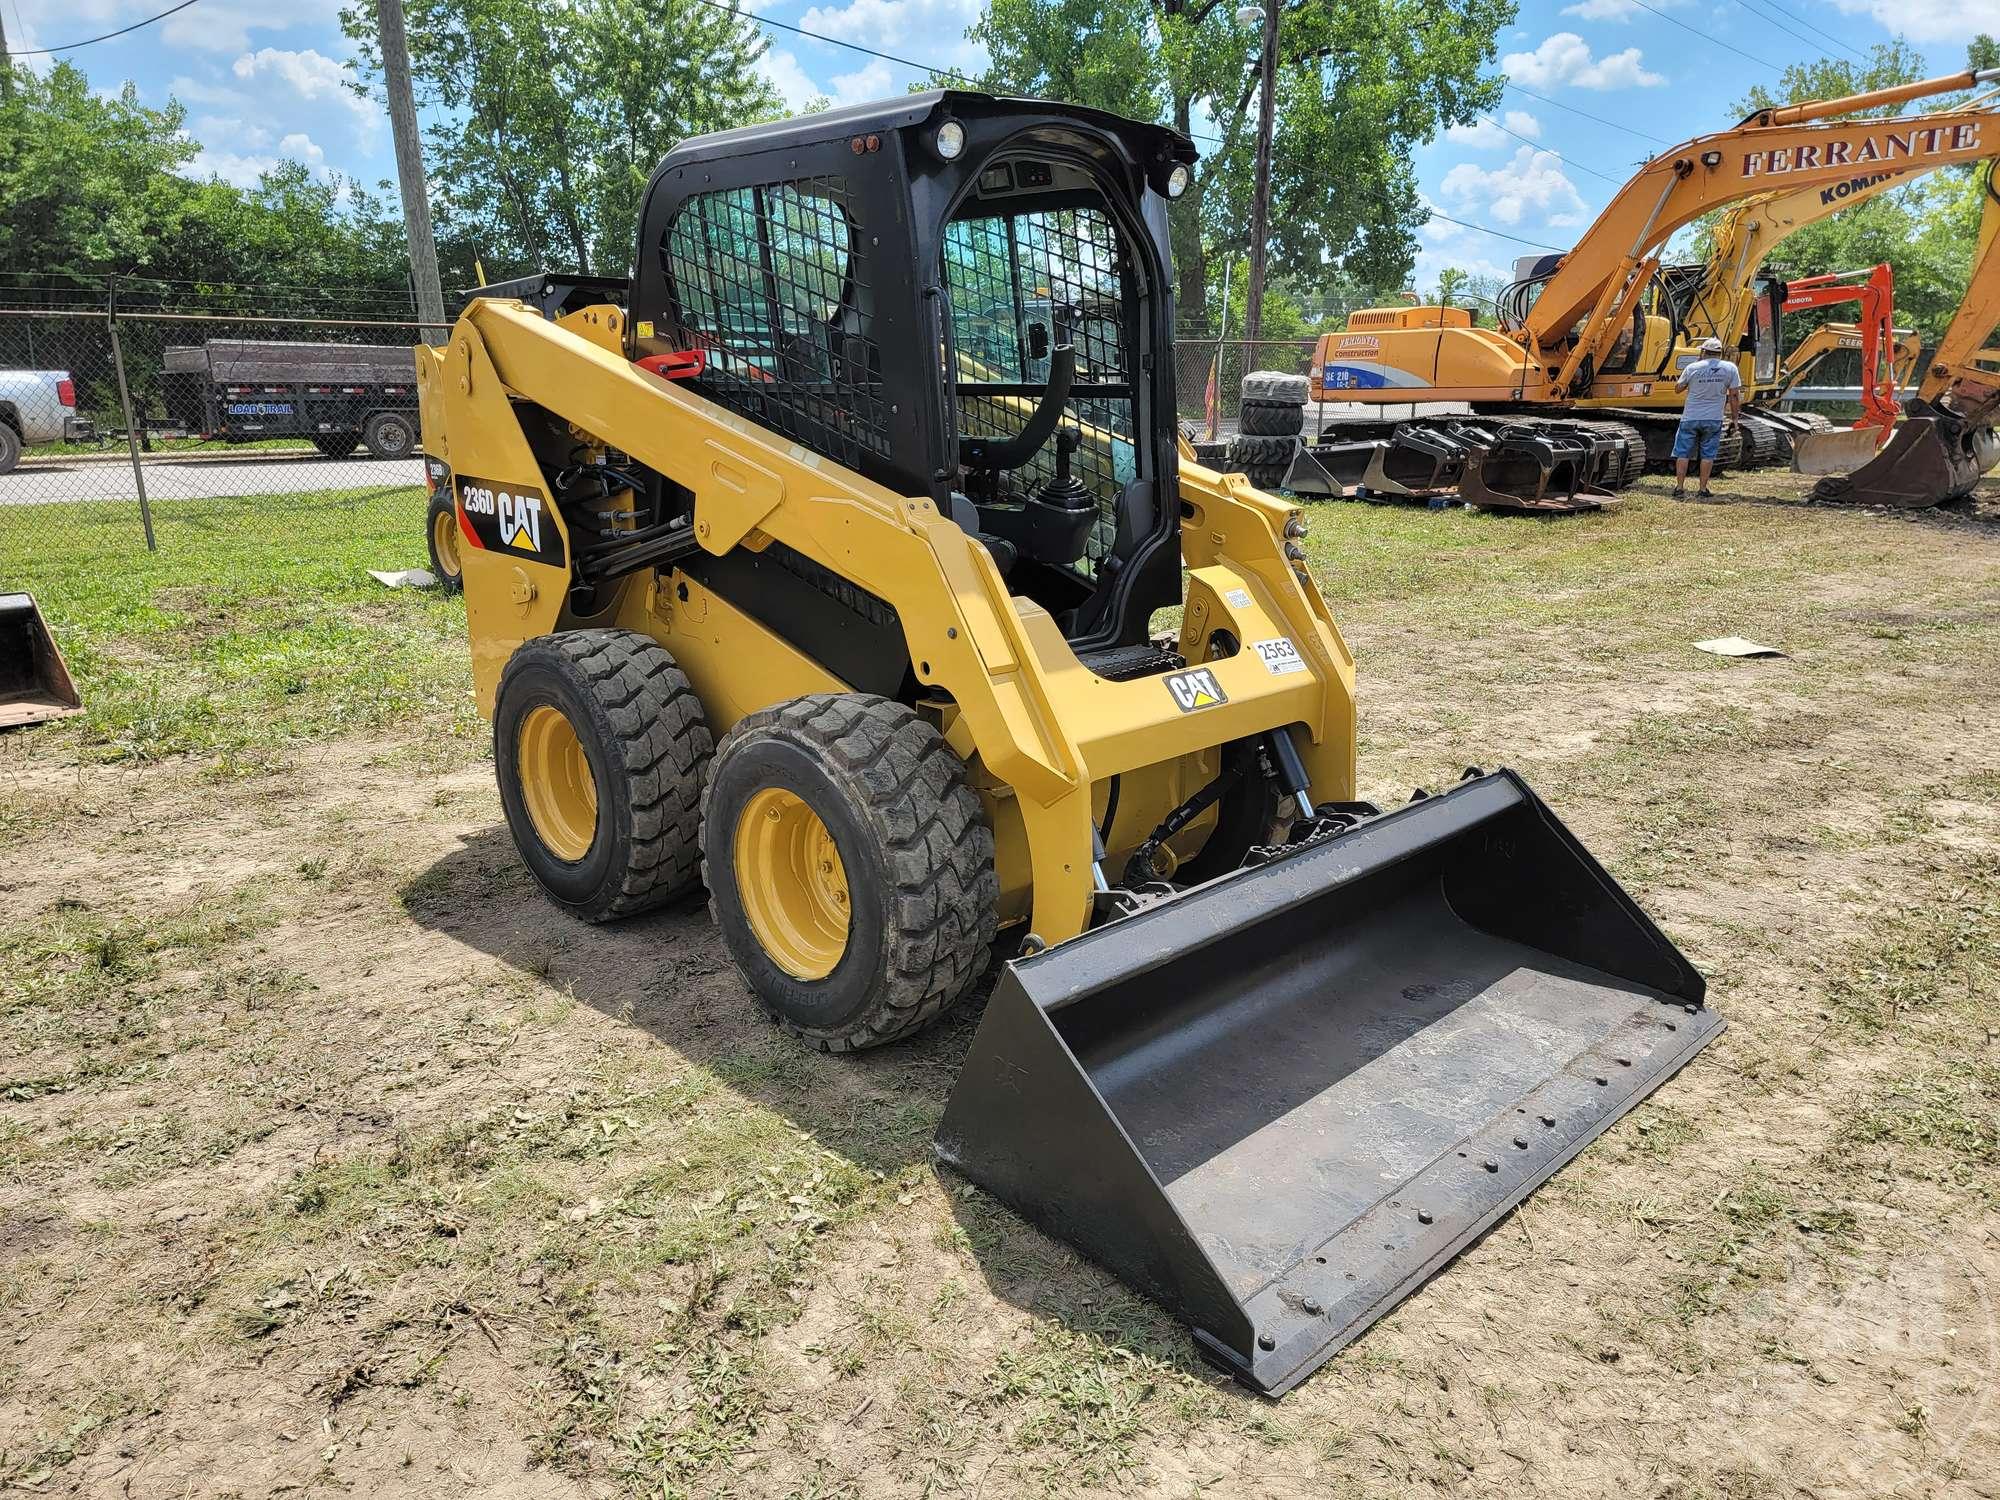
[702,692,1000,1052]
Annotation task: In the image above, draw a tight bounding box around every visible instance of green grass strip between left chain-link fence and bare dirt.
[0,488,474,766]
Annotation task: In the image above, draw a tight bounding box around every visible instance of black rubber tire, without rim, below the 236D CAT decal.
[494,630,714,922]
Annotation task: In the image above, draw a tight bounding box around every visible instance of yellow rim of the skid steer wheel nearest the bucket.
[736,786,848,980]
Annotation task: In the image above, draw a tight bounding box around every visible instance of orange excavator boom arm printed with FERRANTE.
[1522,68,2000,396]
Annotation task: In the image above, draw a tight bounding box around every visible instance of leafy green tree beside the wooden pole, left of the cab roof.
[340,0,780,278]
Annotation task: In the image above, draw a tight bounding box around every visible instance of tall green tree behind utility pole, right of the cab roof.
[968,0,1514,324]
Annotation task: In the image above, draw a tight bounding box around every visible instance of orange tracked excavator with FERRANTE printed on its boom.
[1286,68,2000,510]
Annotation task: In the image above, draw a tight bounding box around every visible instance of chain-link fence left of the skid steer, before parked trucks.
[0,284,444,588]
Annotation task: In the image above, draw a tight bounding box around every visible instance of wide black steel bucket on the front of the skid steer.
[936,772,1722,1396]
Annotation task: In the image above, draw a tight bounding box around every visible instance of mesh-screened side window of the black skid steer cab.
[660,176,890,468]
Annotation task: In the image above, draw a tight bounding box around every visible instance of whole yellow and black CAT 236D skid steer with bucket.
[420,92,1718,1392]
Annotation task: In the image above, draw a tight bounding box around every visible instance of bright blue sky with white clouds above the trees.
[0,0,2000,286]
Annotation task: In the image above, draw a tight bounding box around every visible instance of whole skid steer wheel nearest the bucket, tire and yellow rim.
[702,694,1000,1052]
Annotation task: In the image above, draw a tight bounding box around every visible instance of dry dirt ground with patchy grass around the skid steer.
[0,480,2000,1500]
